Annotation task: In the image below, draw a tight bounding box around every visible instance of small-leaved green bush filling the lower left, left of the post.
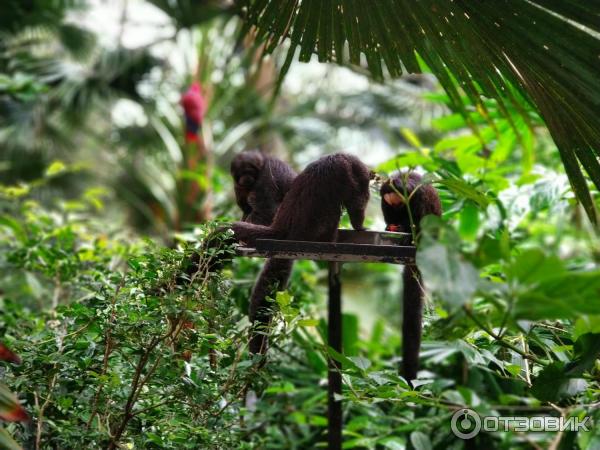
[0,174,325,448]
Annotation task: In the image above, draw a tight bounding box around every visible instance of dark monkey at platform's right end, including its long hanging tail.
[380,172,442,382]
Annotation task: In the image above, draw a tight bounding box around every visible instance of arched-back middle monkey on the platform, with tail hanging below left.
[232,153,371,353]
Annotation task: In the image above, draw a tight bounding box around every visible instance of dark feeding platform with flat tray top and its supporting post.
[237,230,416,450]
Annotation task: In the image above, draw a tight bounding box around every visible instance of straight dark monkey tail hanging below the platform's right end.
[402,265,424,382]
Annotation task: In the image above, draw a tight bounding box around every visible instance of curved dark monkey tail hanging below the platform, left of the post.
[248,259,294,354]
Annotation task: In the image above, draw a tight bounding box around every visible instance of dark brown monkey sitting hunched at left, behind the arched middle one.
[230,150,296,225]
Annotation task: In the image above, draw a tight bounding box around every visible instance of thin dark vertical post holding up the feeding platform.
[327,261,343,450]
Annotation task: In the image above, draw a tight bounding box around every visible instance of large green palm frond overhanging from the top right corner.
[244,0,600,224]
